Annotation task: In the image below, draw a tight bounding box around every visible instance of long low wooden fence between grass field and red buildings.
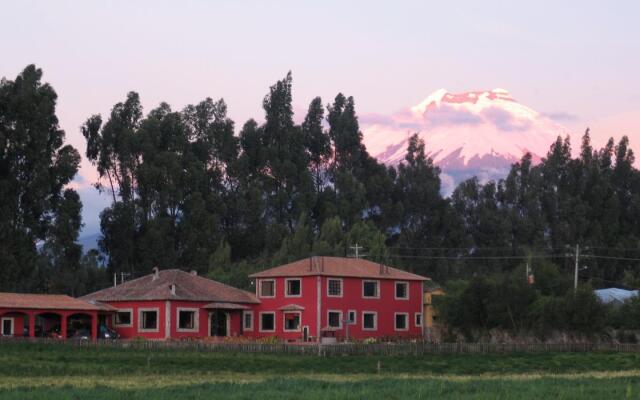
[0,338,640,356]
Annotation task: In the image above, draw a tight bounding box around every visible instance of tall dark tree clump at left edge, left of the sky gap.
[0,65,101,295]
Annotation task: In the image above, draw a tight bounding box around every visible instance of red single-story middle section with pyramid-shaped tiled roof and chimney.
[81,268,260,339]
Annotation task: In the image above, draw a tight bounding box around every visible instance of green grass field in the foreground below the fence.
[0,343,640,400]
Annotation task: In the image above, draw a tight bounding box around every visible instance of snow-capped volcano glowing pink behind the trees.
[362,89,567,192]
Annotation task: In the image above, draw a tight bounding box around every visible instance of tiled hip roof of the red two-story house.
[249,257,429,281]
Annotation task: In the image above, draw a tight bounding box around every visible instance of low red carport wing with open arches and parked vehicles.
[0,293,115,339]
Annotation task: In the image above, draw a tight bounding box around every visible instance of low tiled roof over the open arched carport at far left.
[0,293,112,311]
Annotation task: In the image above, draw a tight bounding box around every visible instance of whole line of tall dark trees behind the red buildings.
[0,65,640,310]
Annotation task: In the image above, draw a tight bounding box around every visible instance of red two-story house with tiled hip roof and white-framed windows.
[248,257,428,340]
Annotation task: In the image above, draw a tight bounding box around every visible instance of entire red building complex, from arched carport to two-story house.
[0,257,428,341]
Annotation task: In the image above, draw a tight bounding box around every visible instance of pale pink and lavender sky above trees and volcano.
[0,0,640,232]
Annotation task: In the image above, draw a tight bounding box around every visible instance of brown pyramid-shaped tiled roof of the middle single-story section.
[82,269,260,303]
